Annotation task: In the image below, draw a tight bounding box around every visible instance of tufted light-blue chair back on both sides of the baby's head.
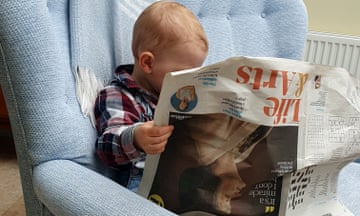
[70,0,307,80]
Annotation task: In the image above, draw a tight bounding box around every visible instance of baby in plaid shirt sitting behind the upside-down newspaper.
[94,1,208,191]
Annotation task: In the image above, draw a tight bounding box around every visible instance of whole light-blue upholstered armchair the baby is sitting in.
[0,0,360,216]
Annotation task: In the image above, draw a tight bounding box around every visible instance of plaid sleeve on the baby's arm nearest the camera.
[94,86,144,166]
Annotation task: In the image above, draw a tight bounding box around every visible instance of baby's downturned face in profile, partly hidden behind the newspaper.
[150,42,207,93]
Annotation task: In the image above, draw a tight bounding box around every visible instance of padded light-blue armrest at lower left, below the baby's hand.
[33,160,175,216]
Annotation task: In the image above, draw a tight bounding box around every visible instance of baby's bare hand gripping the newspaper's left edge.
[134,121,174,154]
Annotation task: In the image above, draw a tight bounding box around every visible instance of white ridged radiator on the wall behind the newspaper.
[303,32,360,78]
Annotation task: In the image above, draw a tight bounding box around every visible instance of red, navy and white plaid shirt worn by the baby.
[94,65,158,167]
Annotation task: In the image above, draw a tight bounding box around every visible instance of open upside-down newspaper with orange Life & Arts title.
[138,57,360,216]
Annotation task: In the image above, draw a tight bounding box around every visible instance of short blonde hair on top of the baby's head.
[132,1,208,58]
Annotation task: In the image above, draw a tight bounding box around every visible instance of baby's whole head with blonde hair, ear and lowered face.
[132,1,208,94]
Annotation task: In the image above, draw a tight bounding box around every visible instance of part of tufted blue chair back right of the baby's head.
[179,0,307,64]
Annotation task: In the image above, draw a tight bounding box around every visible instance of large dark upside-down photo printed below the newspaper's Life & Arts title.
[146,113,297,216]
